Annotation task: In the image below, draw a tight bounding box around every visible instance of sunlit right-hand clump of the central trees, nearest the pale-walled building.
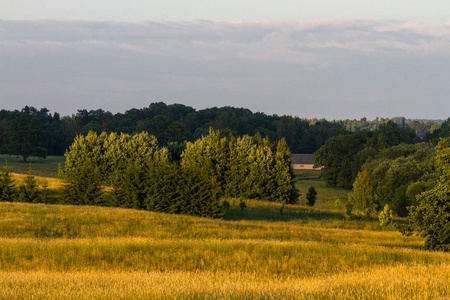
[181,130,298,203]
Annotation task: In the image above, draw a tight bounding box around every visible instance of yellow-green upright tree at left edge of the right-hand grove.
[348,170,377,215]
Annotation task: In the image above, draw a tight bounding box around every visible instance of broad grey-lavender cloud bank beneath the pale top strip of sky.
[0,20,450,119]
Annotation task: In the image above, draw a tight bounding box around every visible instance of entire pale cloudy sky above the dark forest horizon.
[0,0,450,120]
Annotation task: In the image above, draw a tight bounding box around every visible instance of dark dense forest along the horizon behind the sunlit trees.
[0,102,450,160]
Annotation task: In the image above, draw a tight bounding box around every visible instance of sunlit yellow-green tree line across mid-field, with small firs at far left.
[0,129,298,217]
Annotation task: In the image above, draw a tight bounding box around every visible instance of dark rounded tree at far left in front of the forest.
[6,114,47,162]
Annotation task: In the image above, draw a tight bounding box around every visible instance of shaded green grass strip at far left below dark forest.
[0,155,65,178]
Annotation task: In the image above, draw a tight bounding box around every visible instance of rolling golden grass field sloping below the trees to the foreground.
[0,161,450,299]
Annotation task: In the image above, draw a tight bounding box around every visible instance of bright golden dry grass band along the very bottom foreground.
[0,264,450,300]
